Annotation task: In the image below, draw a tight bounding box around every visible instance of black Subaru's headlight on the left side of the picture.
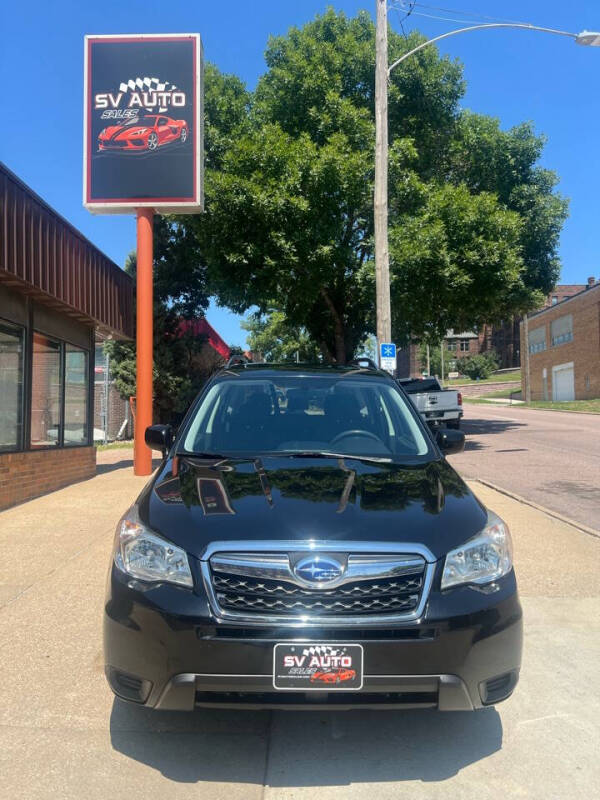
[115,506,194,586]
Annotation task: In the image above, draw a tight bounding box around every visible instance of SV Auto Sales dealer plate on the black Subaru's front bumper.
[273,642,363,692]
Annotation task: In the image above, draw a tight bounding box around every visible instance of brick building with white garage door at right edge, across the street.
[520,278,600,401]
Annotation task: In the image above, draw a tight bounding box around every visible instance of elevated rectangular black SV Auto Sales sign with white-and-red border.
[83,33,203,214]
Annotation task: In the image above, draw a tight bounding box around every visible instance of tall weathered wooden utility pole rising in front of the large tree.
[373,0,392,360]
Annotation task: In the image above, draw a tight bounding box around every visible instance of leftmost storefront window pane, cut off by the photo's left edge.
[0,321,23,451]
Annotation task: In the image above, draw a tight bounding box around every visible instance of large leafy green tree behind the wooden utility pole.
[189,9,566,362]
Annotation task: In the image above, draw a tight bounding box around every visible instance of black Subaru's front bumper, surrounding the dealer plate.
[104,565,522,710]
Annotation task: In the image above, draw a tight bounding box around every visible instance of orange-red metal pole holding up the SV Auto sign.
[133,208,154,475]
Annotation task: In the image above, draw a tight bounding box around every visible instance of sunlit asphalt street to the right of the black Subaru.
[449,403,600,530]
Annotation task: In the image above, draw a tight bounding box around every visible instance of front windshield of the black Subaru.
[183,374,430,460]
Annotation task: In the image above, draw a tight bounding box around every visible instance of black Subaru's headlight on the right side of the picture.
[441,511,512,589]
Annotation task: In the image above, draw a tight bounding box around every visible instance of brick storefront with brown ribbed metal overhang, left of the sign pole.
[0,163,133,509]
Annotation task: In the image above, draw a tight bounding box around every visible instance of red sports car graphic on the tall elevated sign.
[98,114,189,152]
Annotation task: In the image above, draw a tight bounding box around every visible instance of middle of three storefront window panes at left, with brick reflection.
[31,333,62,447]
